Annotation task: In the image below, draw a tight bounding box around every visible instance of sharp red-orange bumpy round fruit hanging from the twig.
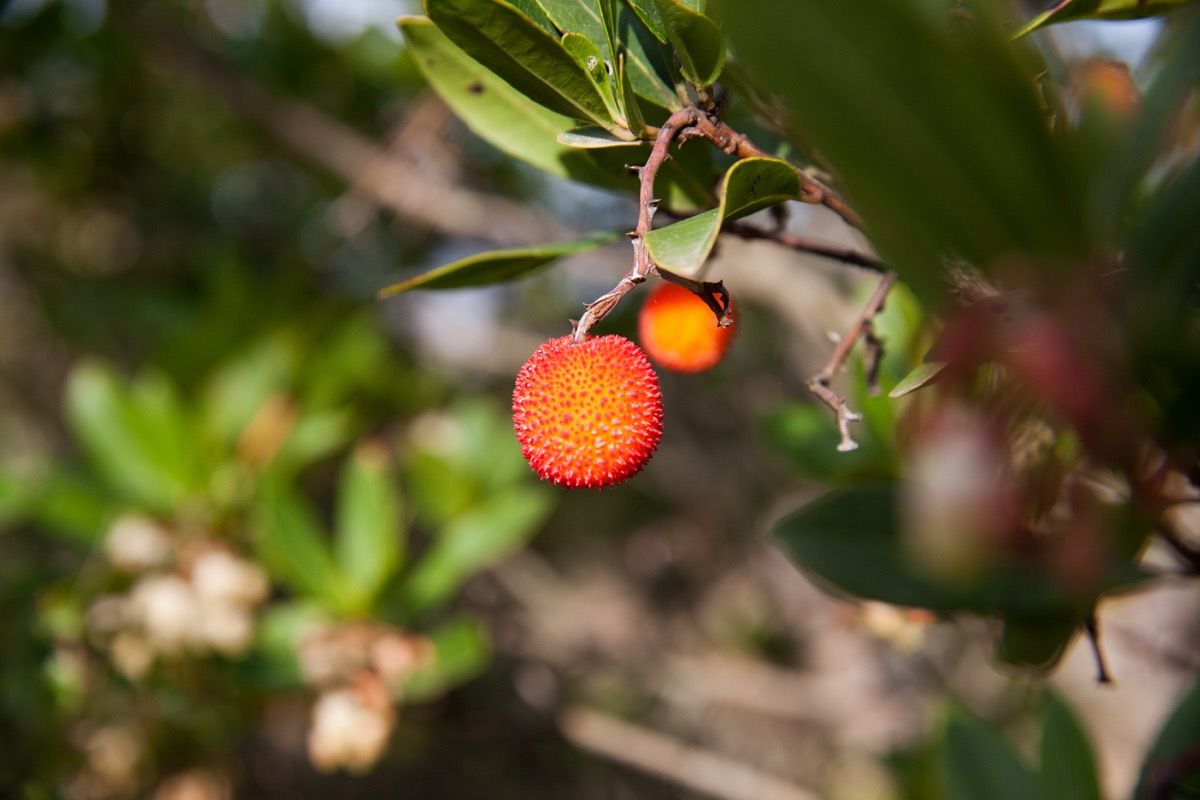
[512,336,662,488]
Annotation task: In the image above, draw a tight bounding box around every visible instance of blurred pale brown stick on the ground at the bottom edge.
[558,705,817,800]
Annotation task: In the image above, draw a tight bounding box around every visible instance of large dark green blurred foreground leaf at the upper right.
[722,0,1088,305]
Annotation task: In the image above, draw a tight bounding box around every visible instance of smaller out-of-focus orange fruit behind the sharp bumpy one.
[637,283,734,372]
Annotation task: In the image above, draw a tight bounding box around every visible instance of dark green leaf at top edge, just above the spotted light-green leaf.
[425,0,612,127]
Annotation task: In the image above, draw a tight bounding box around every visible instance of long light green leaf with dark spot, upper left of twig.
[400,17,652,191]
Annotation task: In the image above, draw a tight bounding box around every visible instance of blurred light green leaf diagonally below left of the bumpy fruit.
[404,487,552,612]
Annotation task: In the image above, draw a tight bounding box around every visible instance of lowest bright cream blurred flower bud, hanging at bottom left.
[308,688,395,772]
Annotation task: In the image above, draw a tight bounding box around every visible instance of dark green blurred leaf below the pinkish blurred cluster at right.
[772,486,1142,618]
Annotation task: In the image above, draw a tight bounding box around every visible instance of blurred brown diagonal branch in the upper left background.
[138,7,571,245]
